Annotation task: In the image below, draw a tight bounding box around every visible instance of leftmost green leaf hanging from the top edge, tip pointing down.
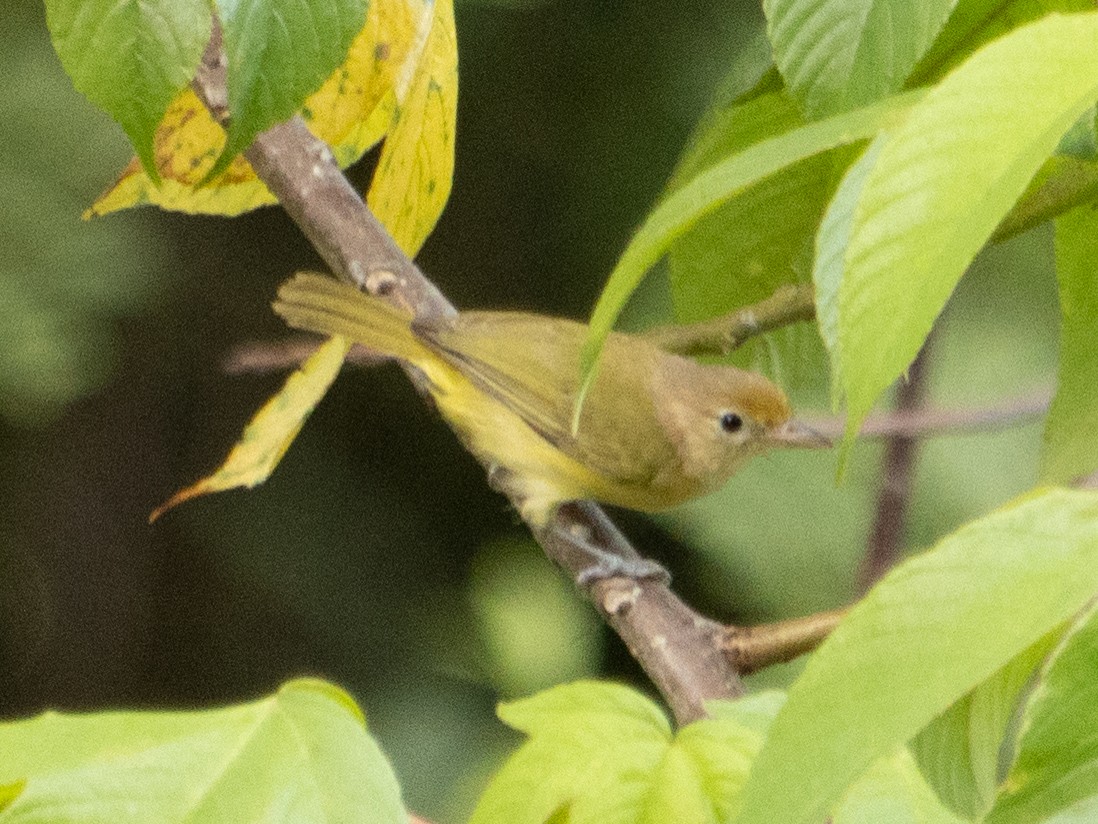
[45,0,211,180]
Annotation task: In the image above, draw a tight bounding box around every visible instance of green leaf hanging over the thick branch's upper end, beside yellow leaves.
[208,0,367,179]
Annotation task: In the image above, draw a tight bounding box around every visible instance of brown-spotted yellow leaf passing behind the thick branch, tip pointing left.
[85,0,429,218]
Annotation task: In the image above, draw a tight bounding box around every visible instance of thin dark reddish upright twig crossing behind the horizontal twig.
[859,338,932,592]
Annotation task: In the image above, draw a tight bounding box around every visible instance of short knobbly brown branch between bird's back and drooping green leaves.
[645,285,816,355]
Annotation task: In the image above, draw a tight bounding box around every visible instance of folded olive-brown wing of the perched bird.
[414,312,673,483]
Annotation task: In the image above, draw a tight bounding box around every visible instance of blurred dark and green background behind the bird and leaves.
[0,0,1056,821]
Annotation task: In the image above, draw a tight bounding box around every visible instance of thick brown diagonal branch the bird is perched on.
[195,24,742,723]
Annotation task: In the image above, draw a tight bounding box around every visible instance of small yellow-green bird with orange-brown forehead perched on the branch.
[273,272,828,536]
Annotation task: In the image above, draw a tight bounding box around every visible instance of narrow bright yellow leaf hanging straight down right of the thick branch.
[367,0,458,256]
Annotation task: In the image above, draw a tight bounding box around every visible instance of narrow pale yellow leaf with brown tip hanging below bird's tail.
[148,337,350,522]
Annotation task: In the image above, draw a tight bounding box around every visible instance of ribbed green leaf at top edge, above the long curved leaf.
[763,0,953,118]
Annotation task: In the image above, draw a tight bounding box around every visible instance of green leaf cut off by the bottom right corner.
[986,609,1098,824]
